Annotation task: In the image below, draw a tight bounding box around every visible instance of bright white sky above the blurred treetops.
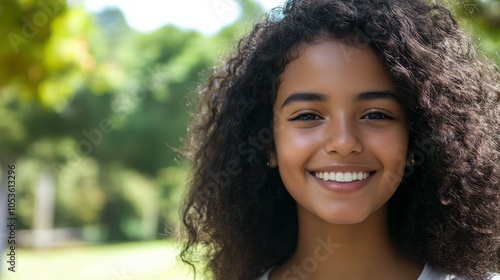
[83,0,283,34]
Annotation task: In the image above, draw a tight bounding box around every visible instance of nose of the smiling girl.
[325,117,363,156]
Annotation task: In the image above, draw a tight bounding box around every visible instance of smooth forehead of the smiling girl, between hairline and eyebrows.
[278,40,396,99]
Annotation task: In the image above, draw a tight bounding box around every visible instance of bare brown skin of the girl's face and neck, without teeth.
[270,39,423,280]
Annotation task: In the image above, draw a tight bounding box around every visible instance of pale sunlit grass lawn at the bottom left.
[0,241,192,280]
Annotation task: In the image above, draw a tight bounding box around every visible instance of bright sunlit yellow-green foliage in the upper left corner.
[0,0,92,107]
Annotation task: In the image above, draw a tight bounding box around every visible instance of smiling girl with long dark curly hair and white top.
[181,0,500,280]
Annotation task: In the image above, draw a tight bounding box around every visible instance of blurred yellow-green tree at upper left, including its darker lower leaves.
[0,0,93,163]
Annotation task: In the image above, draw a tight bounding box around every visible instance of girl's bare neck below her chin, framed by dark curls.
[271,203,422,280]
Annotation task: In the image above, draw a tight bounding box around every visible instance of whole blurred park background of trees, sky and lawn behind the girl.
[0,0,500,280]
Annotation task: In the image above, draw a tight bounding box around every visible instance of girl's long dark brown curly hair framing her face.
[181,0,500,279]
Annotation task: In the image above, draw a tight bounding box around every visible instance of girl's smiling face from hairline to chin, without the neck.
[274,40,408,224]
